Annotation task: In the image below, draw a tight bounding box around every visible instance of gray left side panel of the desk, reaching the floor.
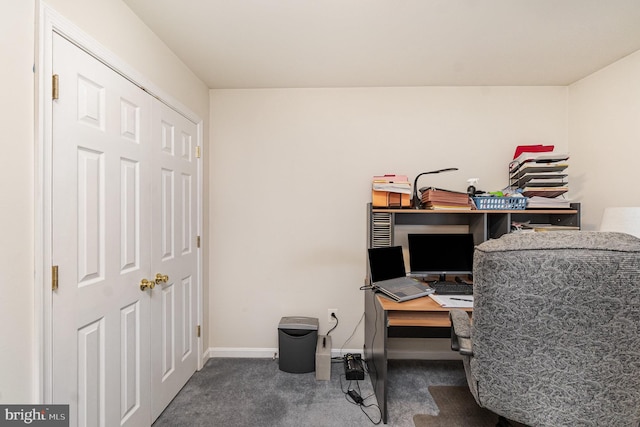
[364,290,387,424]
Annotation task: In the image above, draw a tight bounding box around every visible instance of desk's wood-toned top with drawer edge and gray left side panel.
[364,290,473,424]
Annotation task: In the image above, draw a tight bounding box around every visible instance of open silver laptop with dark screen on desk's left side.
[368,246,433,302]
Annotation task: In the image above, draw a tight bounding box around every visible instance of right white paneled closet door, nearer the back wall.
[151,102,199,420]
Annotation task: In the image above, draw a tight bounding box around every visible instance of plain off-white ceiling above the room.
[123,0,640,89]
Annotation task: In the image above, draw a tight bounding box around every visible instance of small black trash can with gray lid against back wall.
[278,317,319,374]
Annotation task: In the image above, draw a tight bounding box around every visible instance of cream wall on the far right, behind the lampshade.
[569,51,640,230]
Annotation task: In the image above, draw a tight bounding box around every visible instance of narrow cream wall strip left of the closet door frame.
[0,1,35,403]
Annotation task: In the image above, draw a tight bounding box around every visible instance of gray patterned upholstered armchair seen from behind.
[450,231,640,427]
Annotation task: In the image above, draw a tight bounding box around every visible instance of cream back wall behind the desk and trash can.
[209,87,568,350]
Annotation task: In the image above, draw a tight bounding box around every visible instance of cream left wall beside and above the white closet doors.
[0,0,209,403]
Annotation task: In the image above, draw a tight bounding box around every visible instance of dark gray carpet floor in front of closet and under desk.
[153,359,466,427]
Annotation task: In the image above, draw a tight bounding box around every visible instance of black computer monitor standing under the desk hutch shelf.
[408,233,474,280]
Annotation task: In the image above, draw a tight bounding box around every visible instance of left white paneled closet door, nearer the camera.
[51,35,154,427]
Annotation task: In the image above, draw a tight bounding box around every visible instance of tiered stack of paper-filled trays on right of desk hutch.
[509,151,569,203]
